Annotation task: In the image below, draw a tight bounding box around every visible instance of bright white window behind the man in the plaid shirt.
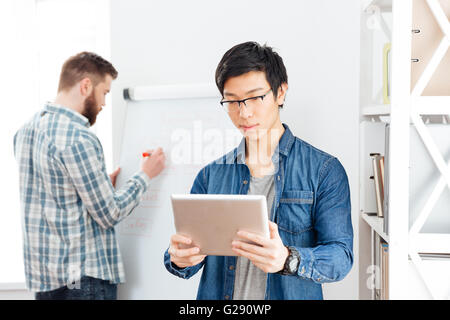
[0,0,112,283]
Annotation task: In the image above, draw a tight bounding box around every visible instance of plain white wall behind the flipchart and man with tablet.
[111,0,360,299]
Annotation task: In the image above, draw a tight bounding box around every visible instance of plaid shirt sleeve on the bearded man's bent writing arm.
[59,139,150,229]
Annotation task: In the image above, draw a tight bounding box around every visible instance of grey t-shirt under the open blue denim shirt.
[233,175,275,300]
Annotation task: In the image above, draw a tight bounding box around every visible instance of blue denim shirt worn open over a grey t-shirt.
[164,124,353,300]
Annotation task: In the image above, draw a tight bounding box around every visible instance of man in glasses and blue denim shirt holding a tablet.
[164,42,353,299]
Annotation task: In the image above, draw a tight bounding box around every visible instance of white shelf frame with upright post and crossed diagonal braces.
[360,0,450,299]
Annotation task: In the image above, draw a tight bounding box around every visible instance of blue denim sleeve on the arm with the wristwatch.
[296,158,353,283]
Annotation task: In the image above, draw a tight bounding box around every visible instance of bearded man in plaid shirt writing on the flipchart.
[14,52,165,299]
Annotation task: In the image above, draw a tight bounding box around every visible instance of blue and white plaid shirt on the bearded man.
[14,104,150,291]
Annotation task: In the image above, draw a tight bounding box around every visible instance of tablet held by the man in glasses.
[171,194,269,256]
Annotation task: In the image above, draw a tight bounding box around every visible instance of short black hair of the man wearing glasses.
[216,41,288,108]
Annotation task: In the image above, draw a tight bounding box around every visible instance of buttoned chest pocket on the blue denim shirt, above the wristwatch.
[277,190,314,234]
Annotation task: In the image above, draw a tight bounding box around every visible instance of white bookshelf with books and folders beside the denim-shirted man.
[358,0,450,299]
